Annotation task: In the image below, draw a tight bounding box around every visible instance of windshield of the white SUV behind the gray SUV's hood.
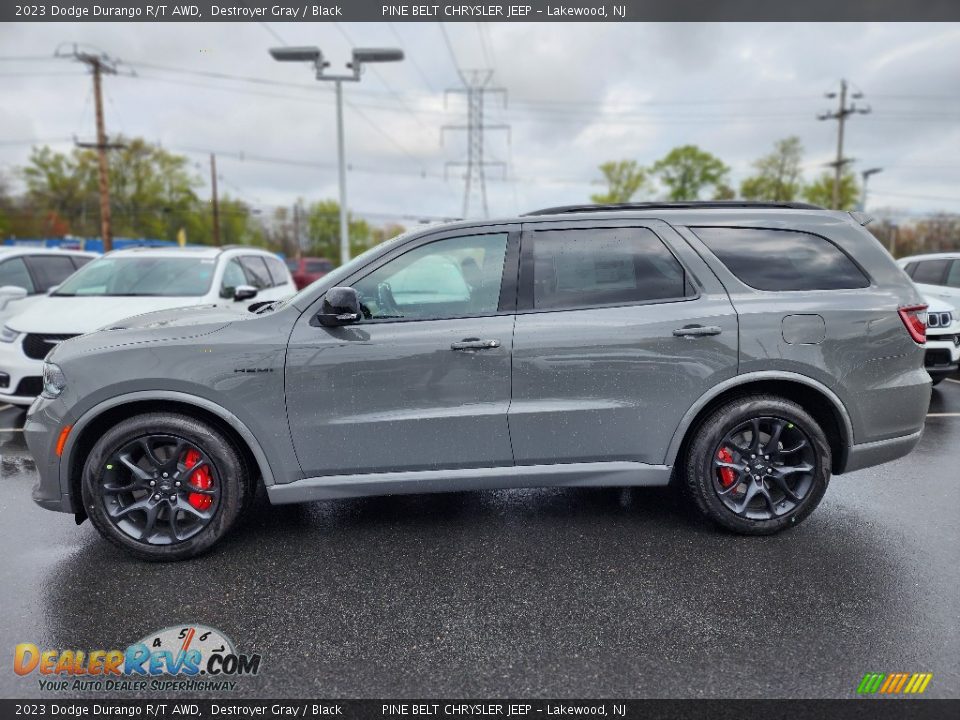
[54,255,216,297]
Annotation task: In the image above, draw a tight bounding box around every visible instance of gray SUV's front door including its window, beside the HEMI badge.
[286,226,518,477]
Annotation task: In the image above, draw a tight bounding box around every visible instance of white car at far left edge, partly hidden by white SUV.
[0,246,98,324]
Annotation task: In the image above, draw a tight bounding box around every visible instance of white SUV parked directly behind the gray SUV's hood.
[0,246,296,405]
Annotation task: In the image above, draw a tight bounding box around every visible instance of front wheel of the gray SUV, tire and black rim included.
[81,413,249,562]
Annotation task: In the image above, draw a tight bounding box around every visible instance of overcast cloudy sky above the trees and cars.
[0,22,960,221]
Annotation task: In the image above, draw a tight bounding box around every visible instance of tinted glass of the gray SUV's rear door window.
[528,228,693,310]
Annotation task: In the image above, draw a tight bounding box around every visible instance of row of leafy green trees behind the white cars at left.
[0,138,403,262]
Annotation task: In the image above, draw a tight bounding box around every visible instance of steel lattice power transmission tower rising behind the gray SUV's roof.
[440,70,510,218]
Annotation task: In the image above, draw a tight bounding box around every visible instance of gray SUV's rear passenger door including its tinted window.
[509,220,738,465]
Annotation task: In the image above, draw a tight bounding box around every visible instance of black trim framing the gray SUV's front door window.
[307,222,520,330]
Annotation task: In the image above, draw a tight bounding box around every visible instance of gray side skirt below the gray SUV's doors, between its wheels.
[267,461,670,505]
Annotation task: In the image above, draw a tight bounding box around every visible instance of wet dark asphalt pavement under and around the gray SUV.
[0,381,960,697]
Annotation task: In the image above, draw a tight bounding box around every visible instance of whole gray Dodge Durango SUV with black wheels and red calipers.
[25,203,930,560]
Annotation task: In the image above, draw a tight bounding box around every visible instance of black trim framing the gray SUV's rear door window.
[517,220,702,315]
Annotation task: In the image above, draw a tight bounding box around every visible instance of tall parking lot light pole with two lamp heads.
[270,47,403,265]
